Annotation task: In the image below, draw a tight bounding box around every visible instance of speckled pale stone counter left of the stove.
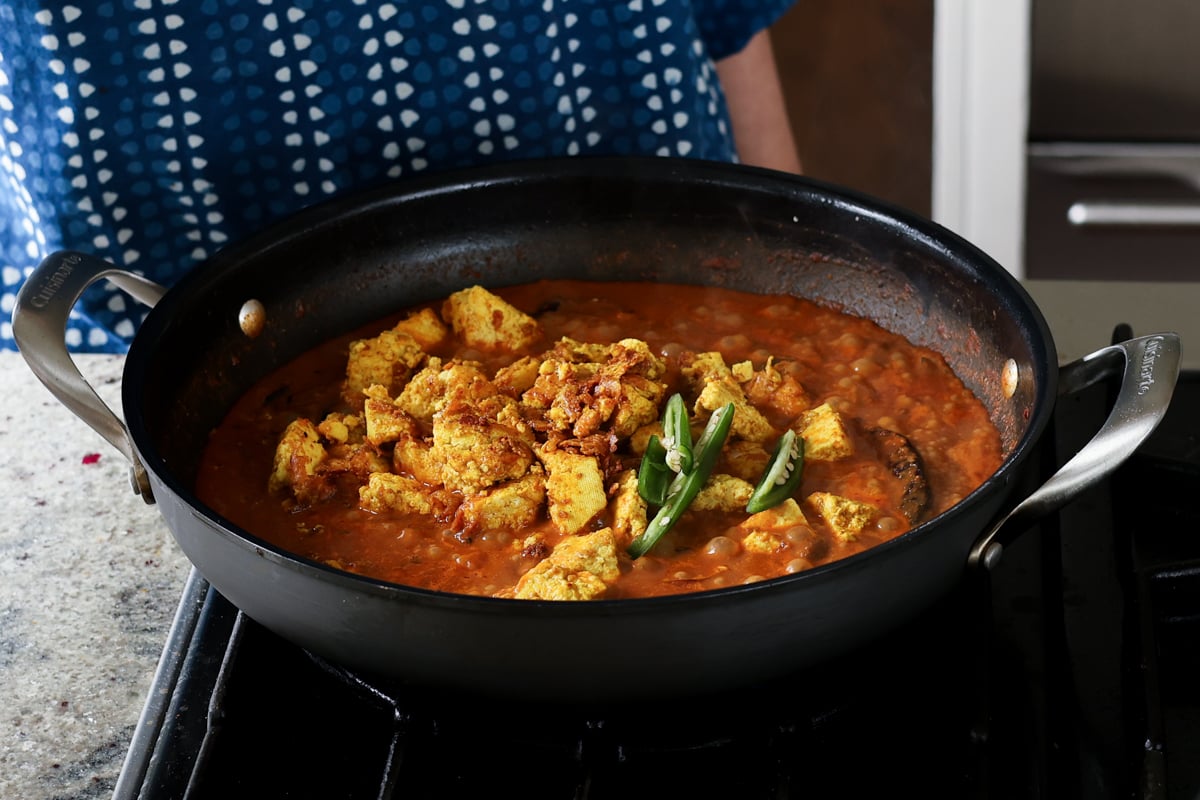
[0,351,190,800]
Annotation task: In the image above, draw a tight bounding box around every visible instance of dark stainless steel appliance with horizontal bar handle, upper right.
[1025,0,1200,281]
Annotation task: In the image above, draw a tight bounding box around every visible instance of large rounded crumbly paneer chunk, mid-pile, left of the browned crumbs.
[430,411,534,494]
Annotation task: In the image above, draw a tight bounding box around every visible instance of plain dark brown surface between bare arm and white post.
[772,0,934,216]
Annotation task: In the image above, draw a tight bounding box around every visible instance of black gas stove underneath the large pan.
[114,287,1200,800]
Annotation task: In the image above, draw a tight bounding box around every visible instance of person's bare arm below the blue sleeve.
[716,30,802,173]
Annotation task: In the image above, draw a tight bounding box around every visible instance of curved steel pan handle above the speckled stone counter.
[12,251,166,503]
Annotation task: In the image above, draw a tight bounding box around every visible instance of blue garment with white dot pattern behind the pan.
[0,0,792,351]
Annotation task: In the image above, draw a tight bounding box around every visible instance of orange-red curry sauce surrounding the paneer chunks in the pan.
[198,281,1001,599]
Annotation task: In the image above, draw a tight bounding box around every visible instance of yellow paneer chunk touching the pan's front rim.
[515,528,620,600]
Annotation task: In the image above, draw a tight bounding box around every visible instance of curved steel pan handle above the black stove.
[967,333,1180,571]
